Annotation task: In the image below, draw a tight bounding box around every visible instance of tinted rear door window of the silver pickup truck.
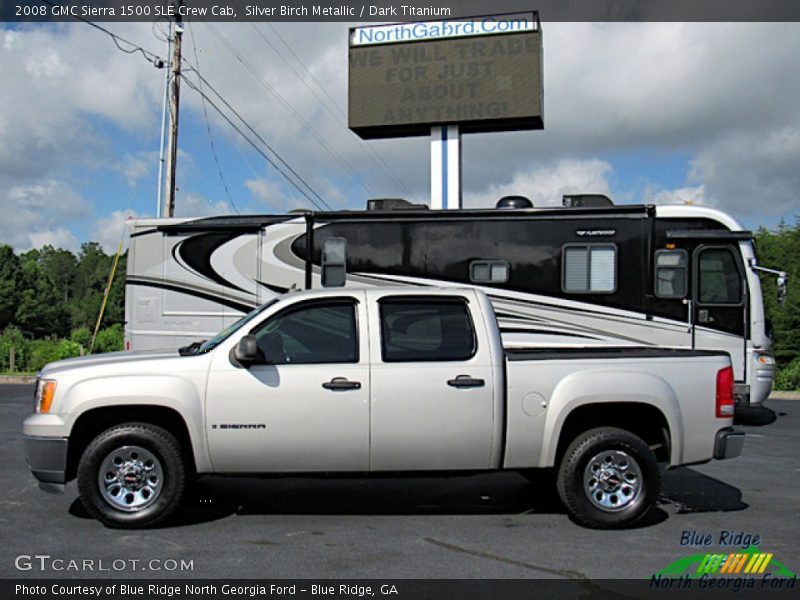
[380,298,477,362]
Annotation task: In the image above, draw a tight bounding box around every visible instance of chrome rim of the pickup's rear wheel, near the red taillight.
[583,450,643,512]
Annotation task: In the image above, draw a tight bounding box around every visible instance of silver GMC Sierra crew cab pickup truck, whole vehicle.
[23,287,744,527]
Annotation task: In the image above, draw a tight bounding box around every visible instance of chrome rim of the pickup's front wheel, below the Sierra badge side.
[97,446,164,512]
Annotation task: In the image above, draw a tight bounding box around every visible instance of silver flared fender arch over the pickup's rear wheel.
[539,369,683,467]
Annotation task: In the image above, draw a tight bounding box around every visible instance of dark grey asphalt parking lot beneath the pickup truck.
[0,385,800,579]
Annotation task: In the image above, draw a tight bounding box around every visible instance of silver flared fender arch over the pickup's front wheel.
[63,375,212,473]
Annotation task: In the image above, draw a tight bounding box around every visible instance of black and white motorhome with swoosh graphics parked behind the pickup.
[125,195,774,406]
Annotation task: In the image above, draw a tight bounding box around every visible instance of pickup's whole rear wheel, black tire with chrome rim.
[557,427,661,529]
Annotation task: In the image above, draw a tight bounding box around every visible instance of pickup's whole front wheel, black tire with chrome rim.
[78,423,187,529]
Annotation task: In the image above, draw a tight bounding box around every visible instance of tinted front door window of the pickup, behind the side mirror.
[252,300,358,365]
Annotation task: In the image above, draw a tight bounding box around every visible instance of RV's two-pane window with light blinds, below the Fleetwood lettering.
[561,244,617,294]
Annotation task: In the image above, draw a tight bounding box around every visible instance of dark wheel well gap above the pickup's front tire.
[67,404,194,481]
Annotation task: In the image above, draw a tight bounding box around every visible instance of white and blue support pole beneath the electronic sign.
[431,125,461,210]
